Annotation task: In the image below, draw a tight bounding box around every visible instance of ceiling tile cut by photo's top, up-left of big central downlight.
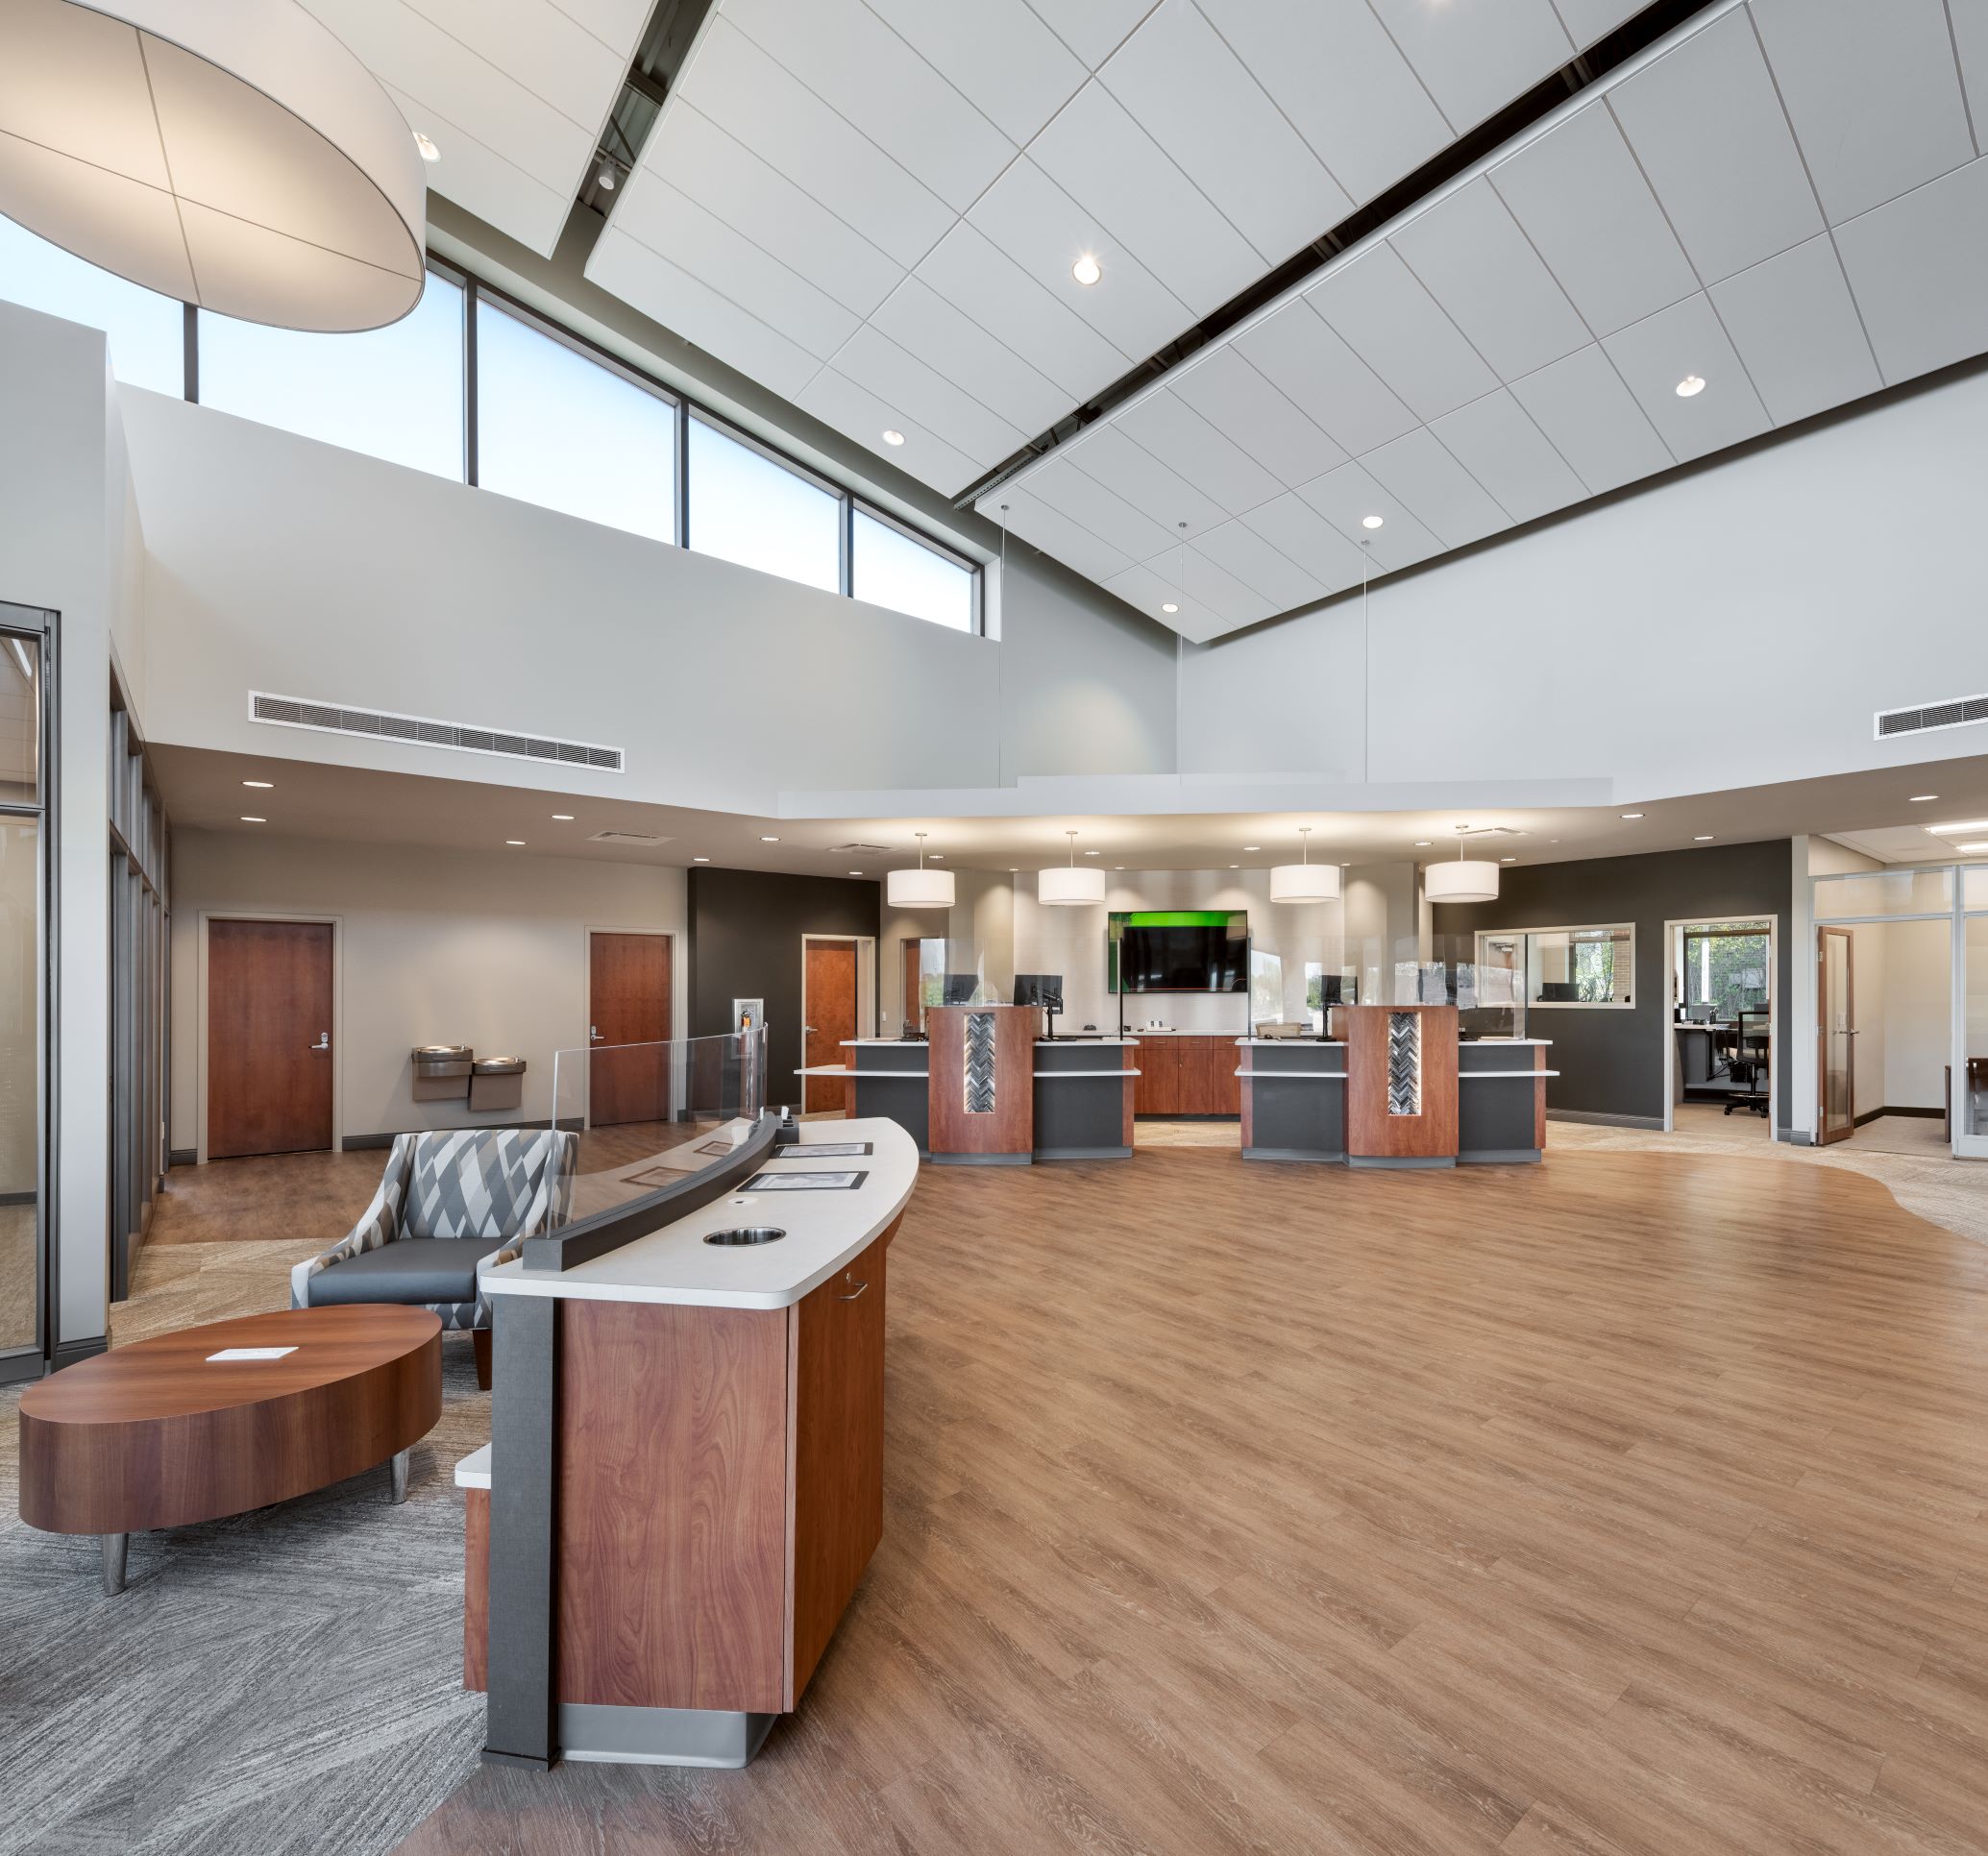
[722,0,1014,211]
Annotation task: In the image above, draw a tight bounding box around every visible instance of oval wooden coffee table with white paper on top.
[20,1304,441,1592]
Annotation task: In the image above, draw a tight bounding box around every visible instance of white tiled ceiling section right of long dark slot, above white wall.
[976,0,1988,642]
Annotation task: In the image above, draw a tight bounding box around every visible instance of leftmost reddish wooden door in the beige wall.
[207,922,332,1160]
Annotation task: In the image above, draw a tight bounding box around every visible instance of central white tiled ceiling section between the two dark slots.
[586,0,1636,501]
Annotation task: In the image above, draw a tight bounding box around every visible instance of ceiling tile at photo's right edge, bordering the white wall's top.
[1837,159,1988,381]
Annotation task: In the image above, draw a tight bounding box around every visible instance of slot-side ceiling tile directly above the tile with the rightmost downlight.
[1491,104,1698,336]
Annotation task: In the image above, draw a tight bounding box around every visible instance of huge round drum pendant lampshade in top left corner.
[0,0,428,330]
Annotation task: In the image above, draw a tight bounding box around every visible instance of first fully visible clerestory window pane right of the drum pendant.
[478,296,675,543]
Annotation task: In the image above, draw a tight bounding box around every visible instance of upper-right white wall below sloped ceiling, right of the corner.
[1181,372,1988,799]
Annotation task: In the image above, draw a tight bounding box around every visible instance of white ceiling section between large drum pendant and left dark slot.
[302,0,650,256]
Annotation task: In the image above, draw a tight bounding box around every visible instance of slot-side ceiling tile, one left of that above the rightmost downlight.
[1389,177,1590,379]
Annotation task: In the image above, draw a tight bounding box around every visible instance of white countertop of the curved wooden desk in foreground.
[483,1119,919,1307]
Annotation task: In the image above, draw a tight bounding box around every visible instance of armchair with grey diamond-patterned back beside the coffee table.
[290,1129,580,1387]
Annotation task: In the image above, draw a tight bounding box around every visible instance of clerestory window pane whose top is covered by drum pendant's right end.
[201,272,463,481]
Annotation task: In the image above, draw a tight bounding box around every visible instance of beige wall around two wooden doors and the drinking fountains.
[171,831,688,1149]
